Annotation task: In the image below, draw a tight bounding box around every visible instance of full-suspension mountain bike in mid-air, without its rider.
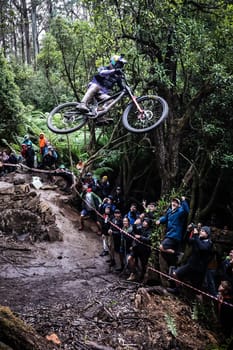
[47,71,169,134]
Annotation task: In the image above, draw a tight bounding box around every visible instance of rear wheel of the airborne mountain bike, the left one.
[47,102,88,134]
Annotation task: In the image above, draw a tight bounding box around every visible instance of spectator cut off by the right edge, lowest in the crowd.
[218,281,233,336]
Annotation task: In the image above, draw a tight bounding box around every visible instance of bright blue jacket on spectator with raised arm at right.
[159,201,189,241]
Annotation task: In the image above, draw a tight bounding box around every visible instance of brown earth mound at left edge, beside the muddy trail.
[0,174,63,242]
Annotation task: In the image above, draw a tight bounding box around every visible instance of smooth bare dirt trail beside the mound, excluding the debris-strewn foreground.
[0,191,114,309]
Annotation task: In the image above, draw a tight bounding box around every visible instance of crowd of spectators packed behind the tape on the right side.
[79,172,233,336]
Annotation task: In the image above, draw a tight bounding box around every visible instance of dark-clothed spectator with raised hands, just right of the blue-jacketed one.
[168,226,213,293]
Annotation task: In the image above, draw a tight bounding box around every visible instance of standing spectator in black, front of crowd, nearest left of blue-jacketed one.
[127,218,152,281]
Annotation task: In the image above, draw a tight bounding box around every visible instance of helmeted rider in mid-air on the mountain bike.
[77,55,127,119]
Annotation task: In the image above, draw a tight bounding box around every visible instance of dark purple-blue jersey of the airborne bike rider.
[91,66,123,94]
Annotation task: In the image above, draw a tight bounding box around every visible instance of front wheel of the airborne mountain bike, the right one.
[122,95,169,133]
